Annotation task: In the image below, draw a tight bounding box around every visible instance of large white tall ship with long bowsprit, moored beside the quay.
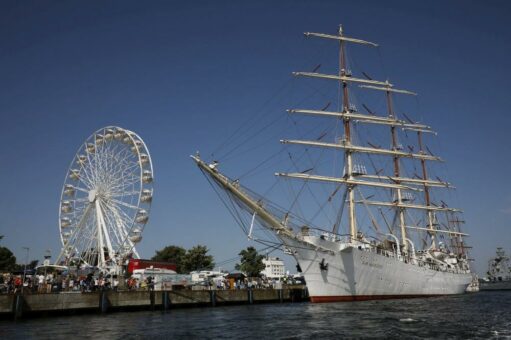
[191,26,472,302]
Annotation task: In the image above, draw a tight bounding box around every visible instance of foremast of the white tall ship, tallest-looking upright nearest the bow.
[339,25,357,242]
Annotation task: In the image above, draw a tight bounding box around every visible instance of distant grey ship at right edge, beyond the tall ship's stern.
[480,247,511,290]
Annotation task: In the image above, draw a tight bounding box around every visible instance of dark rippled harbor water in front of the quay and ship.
[0,291,511,339]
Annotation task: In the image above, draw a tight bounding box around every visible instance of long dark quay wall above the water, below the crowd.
[0,286,308,319]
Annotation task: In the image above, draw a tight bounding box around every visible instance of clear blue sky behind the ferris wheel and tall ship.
[0,1,511,272]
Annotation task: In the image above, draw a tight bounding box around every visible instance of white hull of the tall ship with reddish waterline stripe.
[282,238,472,302]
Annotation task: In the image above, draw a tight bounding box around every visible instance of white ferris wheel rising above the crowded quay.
[57,126,153,272]
